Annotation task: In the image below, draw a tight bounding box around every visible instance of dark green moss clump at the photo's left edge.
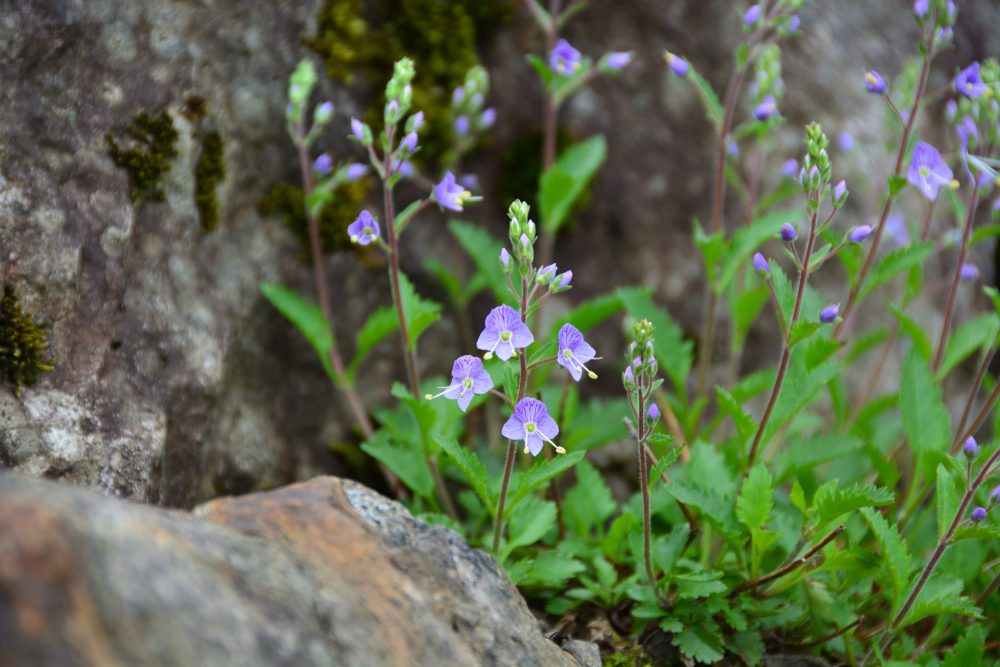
[0,287,55,396]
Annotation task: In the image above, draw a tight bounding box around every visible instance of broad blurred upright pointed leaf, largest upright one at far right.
[899,349,951,470]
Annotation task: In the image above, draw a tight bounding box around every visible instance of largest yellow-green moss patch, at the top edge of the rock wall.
[305,0,513,163]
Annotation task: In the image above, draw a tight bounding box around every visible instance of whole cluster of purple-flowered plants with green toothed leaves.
[261,0,1000,665]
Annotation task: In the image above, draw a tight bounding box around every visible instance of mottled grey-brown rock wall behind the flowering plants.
[0,0,1000,506]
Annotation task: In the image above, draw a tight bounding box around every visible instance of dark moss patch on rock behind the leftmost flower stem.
[257,179,371,254]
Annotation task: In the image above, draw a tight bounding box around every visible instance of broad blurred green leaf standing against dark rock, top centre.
[538,134,608,234]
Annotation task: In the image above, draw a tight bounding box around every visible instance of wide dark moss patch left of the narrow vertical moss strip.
[105,111,179,204]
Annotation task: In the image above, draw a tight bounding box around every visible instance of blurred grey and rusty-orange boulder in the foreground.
[0,473,576,667]
